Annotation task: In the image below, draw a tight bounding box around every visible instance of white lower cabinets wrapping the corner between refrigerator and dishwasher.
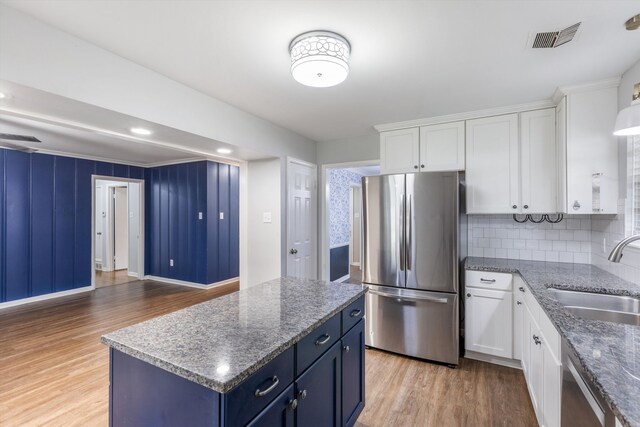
[465,271,562,427]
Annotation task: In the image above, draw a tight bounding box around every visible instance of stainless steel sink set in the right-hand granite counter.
[549,288,640,326]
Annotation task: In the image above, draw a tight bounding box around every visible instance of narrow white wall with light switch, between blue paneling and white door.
[240,159,283,288]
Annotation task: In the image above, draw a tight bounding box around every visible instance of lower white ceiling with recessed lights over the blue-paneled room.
[0,80,270,166]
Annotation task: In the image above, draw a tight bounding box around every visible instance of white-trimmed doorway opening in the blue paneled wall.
[93,177,143,288]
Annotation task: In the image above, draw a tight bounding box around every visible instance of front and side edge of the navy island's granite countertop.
[100,285,369,394]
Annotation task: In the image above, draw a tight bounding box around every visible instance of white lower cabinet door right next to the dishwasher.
[541,341,562,427]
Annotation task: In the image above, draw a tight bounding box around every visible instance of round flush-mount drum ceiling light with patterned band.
[289,31,351,87]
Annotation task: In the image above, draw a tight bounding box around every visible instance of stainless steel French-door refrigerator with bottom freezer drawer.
[362,172,466,365]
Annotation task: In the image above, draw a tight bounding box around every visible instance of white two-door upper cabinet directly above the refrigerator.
[380,121,465,174]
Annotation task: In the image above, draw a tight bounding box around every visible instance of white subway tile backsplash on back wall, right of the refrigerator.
[468,215,592,264]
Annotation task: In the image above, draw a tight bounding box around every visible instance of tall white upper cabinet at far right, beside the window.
[557,86,618,214]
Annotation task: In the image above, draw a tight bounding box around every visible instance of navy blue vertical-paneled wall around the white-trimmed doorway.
[0,149,239,302]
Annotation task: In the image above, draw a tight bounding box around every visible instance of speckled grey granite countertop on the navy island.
[101,277,367,393]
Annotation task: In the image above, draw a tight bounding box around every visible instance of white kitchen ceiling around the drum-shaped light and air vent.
[2,0,640,141]
